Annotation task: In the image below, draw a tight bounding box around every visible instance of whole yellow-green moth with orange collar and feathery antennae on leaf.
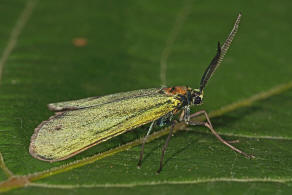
[29,14,253,172]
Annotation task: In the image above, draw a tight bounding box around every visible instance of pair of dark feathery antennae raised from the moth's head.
[200,13,242,92]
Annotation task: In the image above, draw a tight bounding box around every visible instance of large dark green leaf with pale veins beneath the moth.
[0,0,292,194]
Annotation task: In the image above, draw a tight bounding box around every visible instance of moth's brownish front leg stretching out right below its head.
[188,110,255,158]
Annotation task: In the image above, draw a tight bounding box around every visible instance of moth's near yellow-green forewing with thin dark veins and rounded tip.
[30,89,180,161]
